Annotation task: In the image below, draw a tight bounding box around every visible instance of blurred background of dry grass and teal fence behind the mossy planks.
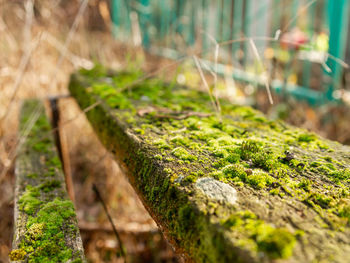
[0,0,350,262]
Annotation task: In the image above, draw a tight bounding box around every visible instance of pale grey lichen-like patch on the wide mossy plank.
[196,177,237,204]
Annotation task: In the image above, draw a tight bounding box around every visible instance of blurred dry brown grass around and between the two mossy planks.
[0,0,176,262]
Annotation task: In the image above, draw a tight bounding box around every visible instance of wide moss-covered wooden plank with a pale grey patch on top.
[69,66,350,262]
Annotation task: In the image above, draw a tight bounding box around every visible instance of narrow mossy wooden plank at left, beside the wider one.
[9,100,84,262]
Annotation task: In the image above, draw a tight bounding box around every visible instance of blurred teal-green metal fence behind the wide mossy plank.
[112,0,350,104]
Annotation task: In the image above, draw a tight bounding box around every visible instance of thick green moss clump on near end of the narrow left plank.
[14,181,77,262]
